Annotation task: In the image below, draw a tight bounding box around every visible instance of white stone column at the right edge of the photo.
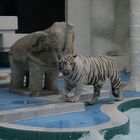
[126,0,140,92]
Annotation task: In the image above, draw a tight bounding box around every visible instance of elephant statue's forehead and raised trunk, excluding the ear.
[44,22,75,57]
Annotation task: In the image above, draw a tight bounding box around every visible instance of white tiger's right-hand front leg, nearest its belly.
[69,82,83,102]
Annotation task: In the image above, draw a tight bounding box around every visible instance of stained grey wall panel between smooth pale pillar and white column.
[90,0,130,71]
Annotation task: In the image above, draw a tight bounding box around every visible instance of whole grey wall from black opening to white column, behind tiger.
[66,0,130,71]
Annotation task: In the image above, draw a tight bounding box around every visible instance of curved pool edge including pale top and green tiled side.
[0,97,140,140]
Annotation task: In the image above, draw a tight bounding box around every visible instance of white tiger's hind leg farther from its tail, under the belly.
[87,82,103,105]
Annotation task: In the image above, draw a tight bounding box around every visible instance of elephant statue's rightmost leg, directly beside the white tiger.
[45,70,59,94]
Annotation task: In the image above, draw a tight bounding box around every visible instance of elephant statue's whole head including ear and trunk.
[30,22,74,66]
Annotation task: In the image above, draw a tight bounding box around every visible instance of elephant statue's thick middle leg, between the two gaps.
[29,62,44,96]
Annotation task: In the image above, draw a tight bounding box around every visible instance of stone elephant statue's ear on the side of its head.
[30,32,48,52]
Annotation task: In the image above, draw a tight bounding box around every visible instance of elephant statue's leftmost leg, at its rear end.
[10,57,25,91]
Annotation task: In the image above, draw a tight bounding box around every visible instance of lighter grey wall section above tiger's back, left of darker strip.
[90,0,114,55]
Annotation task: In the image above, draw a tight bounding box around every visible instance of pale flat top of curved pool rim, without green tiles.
[0,97,137,132]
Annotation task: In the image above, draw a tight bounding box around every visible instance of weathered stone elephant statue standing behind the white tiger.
[9,22,74,96]
